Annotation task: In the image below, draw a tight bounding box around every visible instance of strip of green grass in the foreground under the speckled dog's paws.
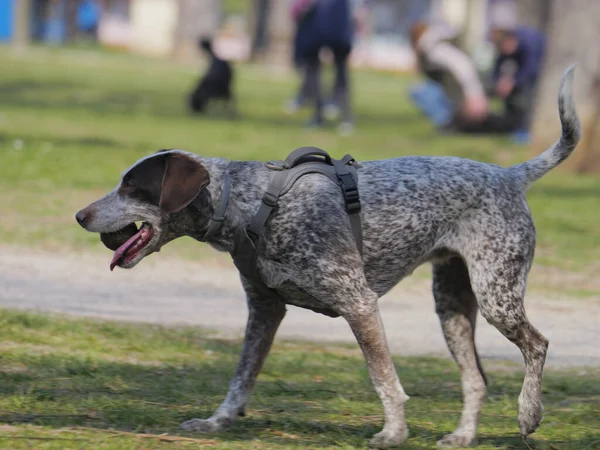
[0,310,600,450]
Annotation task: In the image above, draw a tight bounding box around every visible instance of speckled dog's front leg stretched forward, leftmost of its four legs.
[181,292,285,432]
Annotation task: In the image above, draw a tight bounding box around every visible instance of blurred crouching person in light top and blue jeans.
[410,21,488,130]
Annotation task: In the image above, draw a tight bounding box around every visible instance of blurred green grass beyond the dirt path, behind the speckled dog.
[0,48,600,276]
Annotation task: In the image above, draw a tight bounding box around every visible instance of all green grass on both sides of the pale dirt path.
[0,47,600,450]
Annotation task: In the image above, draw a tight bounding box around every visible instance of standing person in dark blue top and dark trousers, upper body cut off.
[292,0,354,131]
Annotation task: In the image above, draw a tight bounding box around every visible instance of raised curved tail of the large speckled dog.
[510,64,581,187]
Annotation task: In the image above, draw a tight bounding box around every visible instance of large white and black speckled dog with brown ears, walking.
[77,67,580,448]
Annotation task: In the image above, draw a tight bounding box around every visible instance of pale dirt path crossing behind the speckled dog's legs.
[0,247,600,367]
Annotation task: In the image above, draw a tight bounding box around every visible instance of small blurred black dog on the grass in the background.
[188,38,235,113]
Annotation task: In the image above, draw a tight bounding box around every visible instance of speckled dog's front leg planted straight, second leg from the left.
[346,304,408,448]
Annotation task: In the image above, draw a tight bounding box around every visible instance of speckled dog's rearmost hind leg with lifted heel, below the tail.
[467,232,548,437]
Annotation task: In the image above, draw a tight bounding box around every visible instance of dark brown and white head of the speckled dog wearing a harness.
[75,150,210,270]
